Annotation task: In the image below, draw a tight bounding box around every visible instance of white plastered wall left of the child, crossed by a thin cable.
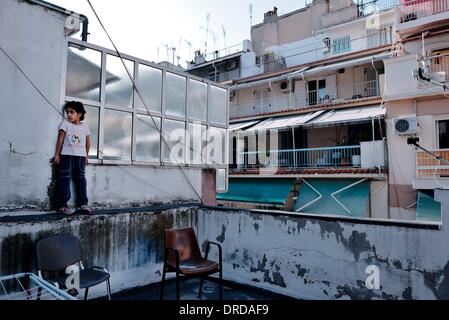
[0,0,65,208]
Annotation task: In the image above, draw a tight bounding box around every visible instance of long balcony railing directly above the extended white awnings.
[230,80,380,118]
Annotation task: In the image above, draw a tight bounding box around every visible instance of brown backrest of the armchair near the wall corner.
[165,228,202,265]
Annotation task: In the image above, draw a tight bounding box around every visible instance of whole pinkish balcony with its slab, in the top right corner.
[396,0,449,36]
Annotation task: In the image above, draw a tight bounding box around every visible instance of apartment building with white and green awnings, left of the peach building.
[186,0,395,219]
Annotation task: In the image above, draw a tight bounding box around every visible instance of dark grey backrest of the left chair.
[36,236,81,271]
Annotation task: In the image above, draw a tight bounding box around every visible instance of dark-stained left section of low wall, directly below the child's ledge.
[0,208,197,297]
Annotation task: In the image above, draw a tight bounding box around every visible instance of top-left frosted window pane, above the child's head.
[66,44,101,101]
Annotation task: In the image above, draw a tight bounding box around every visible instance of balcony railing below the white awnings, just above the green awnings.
[237,146,361,169]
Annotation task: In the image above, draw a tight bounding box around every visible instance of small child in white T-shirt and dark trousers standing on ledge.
[54,101,92,215]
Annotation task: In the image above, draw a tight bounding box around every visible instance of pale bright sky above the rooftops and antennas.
[47,0,306,66]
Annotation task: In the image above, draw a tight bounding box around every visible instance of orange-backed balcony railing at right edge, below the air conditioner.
[416,150,449,177]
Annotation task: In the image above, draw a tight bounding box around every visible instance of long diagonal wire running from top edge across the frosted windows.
[86,0,204,204]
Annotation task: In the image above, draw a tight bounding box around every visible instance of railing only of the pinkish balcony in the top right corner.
[397,0,449,23]
